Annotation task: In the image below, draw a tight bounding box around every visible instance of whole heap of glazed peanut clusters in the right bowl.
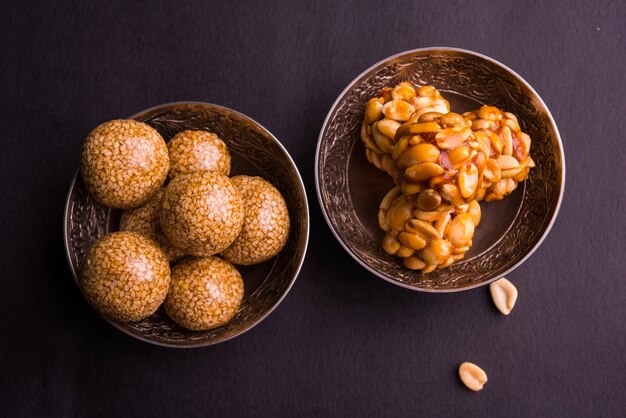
[360,83,535,273]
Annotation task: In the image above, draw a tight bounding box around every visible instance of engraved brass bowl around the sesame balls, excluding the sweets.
[64,103,309,347]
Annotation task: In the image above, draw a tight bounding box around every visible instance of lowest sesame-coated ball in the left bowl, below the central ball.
[164,257,243,331]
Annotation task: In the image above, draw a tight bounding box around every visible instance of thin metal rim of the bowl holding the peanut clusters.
[315,47,566,293]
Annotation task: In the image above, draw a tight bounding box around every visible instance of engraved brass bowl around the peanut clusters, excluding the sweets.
[315,48,565,292]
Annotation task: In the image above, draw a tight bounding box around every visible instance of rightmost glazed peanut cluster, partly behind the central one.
[463,106,535,202]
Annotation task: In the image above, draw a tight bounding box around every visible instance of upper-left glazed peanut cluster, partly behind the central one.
[361,82,450,175]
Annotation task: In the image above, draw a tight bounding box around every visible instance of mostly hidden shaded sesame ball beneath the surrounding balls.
[120,189,185,263]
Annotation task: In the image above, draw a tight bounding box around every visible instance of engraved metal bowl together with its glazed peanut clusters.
[315,48,565,292]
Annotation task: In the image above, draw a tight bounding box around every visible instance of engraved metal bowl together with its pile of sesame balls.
[65,103,309,347]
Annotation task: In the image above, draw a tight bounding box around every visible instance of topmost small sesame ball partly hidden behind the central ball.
[167,131,230,178]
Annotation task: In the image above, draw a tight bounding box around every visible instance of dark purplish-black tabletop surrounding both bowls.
[0,0,626,417]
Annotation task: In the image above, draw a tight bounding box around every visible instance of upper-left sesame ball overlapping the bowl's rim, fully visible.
[80,120,170,209]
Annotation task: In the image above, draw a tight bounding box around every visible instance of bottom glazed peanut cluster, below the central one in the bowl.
[378,187,481,273]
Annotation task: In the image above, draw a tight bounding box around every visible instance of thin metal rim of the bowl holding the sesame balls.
[63,101,311,349]
